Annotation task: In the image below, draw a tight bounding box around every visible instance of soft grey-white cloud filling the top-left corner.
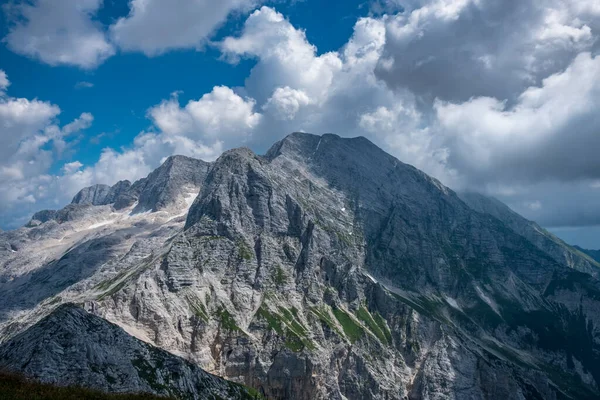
[4,0,115,69]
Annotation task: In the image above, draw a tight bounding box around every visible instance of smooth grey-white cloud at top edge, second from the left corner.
[110,0,255,56]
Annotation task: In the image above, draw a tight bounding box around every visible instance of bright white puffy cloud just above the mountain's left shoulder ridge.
[47,86,261,211]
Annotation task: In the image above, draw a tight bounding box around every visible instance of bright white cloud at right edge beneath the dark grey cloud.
[435,53,600,185]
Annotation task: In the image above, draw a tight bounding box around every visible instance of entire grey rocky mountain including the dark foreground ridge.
[0,133,600,400]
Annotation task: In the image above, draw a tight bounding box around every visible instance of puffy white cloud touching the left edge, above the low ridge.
[0,71,93,226]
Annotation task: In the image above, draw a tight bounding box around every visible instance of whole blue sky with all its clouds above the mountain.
[0,0,600,248]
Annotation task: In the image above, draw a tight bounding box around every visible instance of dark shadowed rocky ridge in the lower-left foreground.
[0,304,253,399]
